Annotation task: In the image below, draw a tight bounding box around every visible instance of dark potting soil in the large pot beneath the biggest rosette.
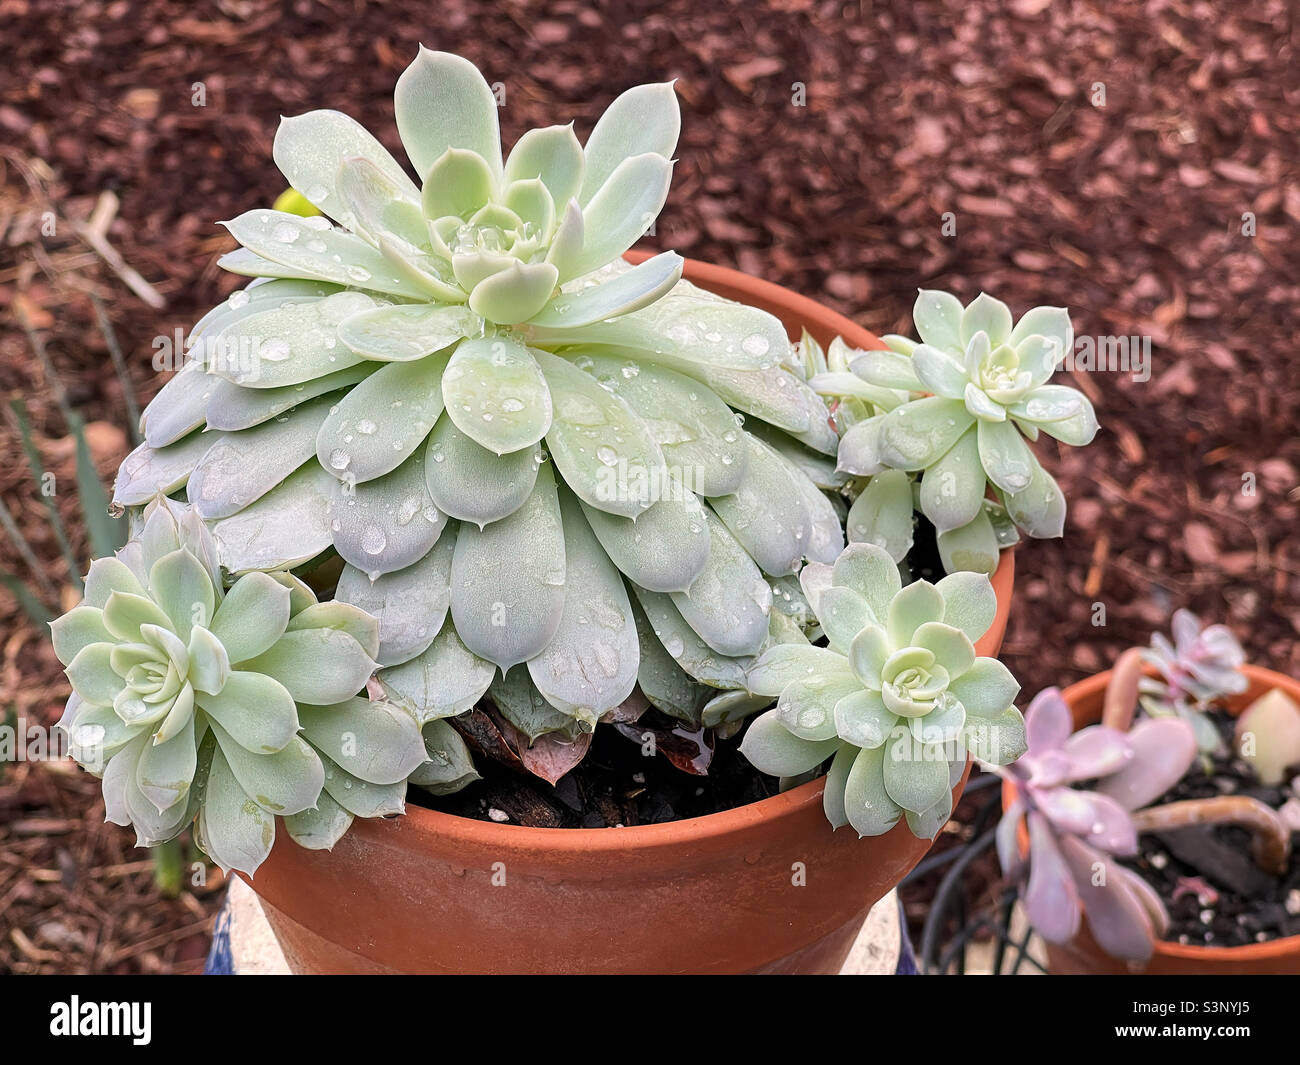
[407,710,777,828]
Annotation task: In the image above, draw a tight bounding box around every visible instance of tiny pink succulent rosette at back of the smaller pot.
[1138,610,1248,752]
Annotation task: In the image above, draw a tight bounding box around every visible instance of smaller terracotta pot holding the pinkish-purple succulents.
[1002,666,1300,977]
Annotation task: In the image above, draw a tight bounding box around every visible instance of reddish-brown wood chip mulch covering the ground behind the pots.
[0,0,1300,971]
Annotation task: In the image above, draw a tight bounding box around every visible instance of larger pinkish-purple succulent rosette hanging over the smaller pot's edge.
[997,688,1196,962]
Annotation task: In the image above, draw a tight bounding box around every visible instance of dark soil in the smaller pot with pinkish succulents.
[1126,710,1300,947]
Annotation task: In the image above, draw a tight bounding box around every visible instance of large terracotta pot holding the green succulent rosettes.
[244,256,1014,973]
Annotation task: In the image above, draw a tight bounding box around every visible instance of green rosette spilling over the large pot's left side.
[52,499,425,874]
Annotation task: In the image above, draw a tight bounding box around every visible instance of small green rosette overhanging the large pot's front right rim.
[741,544,1024,839]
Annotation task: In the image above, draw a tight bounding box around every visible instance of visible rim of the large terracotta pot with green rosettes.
[390,251,1015,854]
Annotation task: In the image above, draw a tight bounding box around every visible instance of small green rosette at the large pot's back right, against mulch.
[810,289,1097,572]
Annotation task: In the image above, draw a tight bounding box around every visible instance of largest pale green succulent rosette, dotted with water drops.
[114,49,844,776]
